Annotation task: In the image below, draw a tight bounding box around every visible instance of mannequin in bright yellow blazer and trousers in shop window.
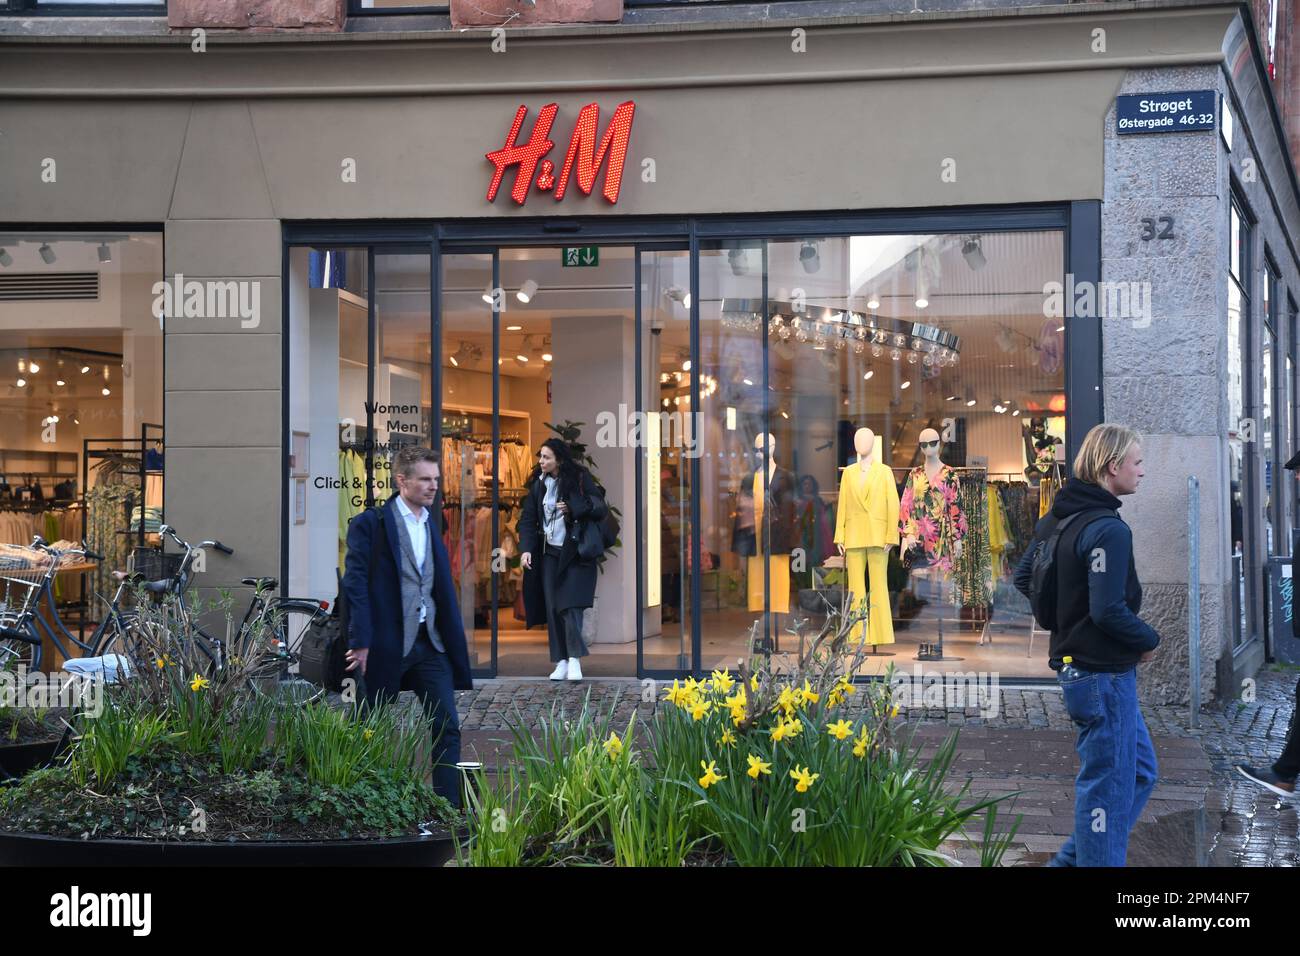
[835,462,898,644]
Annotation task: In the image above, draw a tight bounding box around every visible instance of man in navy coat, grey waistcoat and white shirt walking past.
[343,446,473,806]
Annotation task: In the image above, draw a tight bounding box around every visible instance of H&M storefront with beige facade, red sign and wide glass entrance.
[0,0,1284,680]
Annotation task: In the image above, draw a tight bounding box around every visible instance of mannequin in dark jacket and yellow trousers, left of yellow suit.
[732,434,798,614]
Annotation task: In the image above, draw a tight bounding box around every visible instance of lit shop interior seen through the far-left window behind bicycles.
[0,232,165,661]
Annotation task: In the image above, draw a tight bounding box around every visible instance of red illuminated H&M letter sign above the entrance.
[486,100,637,206]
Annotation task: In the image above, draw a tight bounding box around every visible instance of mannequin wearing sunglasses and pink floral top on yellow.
[898,428,966,571]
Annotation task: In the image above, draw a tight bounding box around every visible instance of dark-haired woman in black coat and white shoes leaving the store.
[517,438,608,680]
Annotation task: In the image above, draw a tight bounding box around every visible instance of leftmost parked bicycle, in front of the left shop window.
[0,535,139,671]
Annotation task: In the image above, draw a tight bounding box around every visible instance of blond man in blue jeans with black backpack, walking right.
[1015,424,1160,866]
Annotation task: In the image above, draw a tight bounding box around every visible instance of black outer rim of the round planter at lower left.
[0,830,455,866]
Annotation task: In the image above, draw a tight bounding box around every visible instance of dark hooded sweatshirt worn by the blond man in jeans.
[1015,477,1160,671]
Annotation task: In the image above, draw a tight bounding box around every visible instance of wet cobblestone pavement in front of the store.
[456,669,1300,866]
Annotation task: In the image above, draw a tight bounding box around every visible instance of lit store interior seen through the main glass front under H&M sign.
[290,232,1065,679]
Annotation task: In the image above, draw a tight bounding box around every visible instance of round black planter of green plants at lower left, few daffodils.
[0,590,455,865]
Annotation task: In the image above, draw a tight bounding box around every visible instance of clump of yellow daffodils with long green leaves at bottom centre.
[458,604,1018,866]
